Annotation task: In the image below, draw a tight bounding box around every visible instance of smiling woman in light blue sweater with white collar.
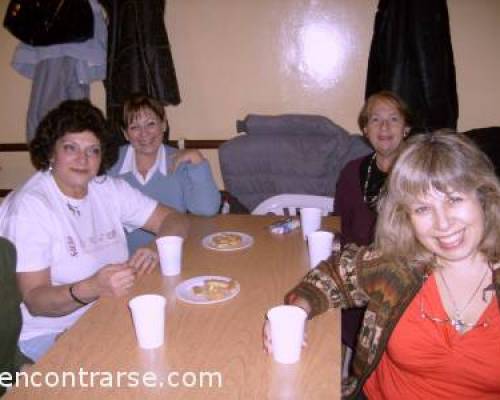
[109,94,221,251]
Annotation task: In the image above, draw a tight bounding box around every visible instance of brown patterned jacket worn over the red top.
[285,245,500,399]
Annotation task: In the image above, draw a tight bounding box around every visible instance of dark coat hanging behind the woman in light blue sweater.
[100,0,180,136]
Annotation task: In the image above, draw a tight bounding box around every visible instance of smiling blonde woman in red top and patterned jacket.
[266,132,500,400]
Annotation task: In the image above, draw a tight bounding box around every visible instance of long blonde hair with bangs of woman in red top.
[375,131,500,262]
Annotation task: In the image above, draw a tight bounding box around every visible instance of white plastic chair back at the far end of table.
[252,193,334,215]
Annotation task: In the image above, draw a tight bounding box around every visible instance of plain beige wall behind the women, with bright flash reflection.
[0,0,500,188]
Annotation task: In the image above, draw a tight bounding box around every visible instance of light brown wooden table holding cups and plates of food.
[5,215,340,400]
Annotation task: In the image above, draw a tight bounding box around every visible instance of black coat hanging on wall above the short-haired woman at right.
[365,0,458,131]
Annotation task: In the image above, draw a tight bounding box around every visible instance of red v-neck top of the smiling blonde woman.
[363,276,500,400]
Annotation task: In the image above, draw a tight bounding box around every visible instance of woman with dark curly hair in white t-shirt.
[0,100,187,361]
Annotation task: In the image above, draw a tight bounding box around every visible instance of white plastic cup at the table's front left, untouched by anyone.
[128,294,167,349]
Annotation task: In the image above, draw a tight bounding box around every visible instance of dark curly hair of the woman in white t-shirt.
[29,99,117,175]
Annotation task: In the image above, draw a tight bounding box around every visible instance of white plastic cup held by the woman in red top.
[267,305,307,364]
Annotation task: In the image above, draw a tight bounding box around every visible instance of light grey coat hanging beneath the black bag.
[8,0,107,142]
